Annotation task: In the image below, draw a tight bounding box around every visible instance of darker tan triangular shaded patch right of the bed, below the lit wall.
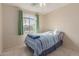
[63,33,79,50]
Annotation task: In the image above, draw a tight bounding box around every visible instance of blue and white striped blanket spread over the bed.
[25,32,63,56]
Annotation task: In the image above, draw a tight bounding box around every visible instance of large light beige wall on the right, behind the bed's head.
[43,4,79,46]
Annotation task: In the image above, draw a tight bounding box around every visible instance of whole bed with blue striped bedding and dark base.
[25,31,64,56]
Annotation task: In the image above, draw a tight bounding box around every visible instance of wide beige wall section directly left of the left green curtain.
[2,4,42,49]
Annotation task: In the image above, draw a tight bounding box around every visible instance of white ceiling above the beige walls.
[7,3,68,14]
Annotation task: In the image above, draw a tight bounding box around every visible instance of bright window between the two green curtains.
[23,15,36,33]
